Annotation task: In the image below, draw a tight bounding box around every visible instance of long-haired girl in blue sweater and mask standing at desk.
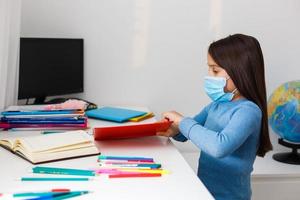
[158,34,272,200]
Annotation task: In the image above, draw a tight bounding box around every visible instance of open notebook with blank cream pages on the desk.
[0,130,100,164]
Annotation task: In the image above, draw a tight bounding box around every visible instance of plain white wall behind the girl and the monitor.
[21,0,300,155]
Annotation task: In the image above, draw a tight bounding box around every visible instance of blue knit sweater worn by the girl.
[173,99,262,200]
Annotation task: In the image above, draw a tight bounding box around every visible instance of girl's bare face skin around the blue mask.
[207,53,236,92]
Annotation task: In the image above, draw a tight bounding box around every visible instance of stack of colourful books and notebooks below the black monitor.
[0,109,87,130]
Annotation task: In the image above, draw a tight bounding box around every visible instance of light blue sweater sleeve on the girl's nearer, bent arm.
[179,107,261,158]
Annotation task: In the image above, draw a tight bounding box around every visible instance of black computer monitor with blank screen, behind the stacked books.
[18,38,83,104]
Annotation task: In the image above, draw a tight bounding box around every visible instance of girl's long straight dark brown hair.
[208,34,272,157]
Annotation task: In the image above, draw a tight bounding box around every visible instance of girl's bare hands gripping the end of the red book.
[157,111,183,137]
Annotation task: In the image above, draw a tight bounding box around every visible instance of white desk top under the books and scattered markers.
[0,106,213,200]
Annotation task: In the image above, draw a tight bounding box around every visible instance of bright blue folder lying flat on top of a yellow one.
[86,107,147,122]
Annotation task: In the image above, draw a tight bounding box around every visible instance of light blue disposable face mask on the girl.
[204,76,237,102]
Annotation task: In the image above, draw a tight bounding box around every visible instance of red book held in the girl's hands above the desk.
[94,121,172,140]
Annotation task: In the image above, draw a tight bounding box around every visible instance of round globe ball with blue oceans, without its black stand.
[268,80,300,143]
